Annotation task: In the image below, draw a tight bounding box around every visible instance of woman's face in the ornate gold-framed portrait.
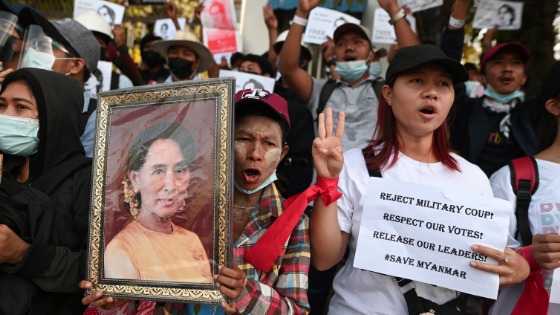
[128,139,190,218]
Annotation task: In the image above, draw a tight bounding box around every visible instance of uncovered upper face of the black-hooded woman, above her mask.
[0,81,39,119]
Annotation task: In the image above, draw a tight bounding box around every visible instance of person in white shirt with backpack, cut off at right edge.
[490,62,560,315]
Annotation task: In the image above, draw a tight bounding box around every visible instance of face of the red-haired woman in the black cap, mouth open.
[384,65,455,138]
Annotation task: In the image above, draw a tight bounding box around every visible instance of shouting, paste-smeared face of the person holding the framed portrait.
[233,115,287,190]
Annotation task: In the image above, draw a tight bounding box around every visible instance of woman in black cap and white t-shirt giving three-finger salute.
[310,45,529,314]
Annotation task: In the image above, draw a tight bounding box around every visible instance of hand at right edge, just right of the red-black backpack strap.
[531,234,560,270]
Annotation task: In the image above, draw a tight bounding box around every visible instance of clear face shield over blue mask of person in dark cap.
[18,25,75,70]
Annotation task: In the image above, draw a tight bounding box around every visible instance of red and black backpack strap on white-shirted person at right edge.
[508,156,539,245]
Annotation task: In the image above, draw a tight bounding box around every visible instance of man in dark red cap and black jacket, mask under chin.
[451,42,542,176]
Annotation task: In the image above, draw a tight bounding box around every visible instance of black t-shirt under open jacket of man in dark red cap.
[476,111,525,177]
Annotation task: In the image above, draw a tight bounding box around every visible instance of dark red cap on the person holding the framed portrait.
[235,89,290,130]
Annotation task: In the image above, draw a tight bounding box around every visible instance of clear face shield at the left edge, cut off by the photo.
[0,11,21,69]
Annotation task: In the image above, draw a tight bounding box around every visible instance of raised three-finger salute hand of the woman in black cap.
[311,108,345,178]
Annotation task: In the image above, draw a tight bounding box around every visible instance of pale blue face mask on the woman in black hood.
[0,114,39,157]
